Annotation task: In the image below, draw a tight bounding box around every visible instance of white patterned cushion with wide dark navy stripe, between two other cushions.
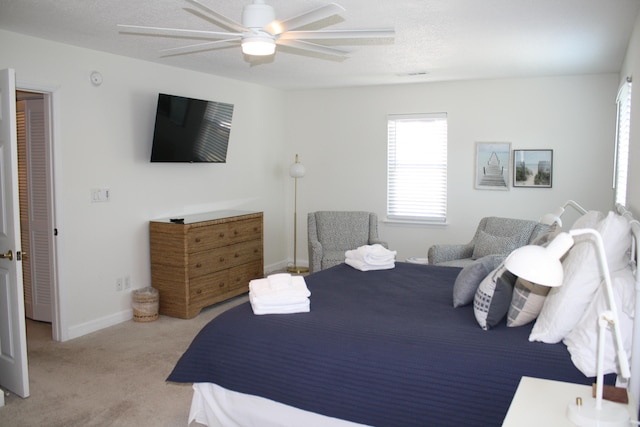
[473,264,516,330]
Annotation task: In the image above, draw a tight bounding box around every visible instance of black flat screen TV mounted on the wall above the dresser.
[151,93,233,163]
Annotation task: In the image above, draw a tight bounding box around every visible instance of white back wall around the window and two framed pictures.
[286,74,618,260]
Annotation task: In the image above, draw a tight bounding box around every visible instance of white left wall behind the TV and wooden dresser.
[0,31,289,339]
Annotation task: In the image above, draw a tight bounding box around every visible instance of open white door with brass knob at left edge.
[0,69,29,397]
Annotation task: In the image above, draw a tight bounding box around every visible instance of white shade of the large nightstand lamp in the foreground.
[504,233,574,287]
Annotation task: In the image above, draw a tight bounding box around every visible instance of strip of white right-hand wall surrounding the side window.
[620,11,640,218]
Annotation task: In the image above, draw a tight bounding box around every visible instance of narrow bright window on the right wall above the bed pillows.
[613,77,631,205]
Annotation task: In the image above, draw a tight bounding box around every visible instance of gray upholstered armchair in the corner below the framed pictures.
[427,217,549,267]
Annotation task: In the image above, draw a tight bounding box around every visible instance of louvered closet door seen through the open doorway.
[23,99,53,322]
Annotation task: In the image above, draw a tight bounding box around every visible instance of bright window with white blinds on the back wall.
[387,113,447,223]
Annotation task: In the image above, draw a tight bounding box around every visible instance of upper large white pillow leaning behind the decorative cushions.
[529,211,631,343]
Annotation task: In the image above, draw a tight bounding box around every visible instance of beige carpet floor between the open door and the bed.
[0,296,247,427]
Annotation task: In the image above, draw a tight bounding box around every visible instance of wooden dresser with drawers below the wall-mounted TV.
[149,210,264,319]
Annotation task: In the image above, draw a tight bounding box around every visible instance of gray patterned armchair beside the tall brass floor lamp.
[307,211,387,273]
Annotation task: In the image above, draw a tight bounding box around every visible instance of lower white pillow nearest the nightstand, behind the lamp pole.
[563,267,635,377]
